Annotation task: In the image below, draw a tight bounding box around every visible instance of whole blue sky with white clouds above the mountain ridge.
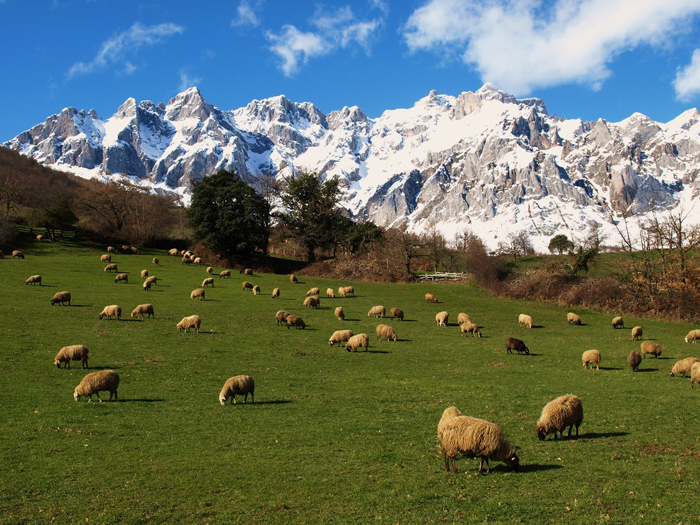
[0,0,700,141]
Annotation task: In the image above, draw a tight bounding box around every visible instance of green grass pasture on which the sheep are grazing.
[0,239,700,524]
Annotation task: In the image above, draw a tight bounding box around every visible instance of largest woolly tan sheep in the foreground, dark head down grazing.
[438,407,520,474]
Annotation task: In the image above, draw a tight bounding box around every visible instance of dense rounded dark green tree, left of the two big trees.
[187,170,270,256]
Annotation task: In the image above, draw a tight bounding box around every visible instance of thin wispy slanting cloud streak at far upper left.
[66,22,185,79]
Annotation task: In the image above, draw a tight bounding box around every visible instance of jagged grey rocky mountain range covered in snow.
[3,85,700,251]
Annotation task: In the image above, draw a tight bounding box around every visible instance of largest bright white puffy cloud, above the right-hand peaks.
[403,0,700,95]
